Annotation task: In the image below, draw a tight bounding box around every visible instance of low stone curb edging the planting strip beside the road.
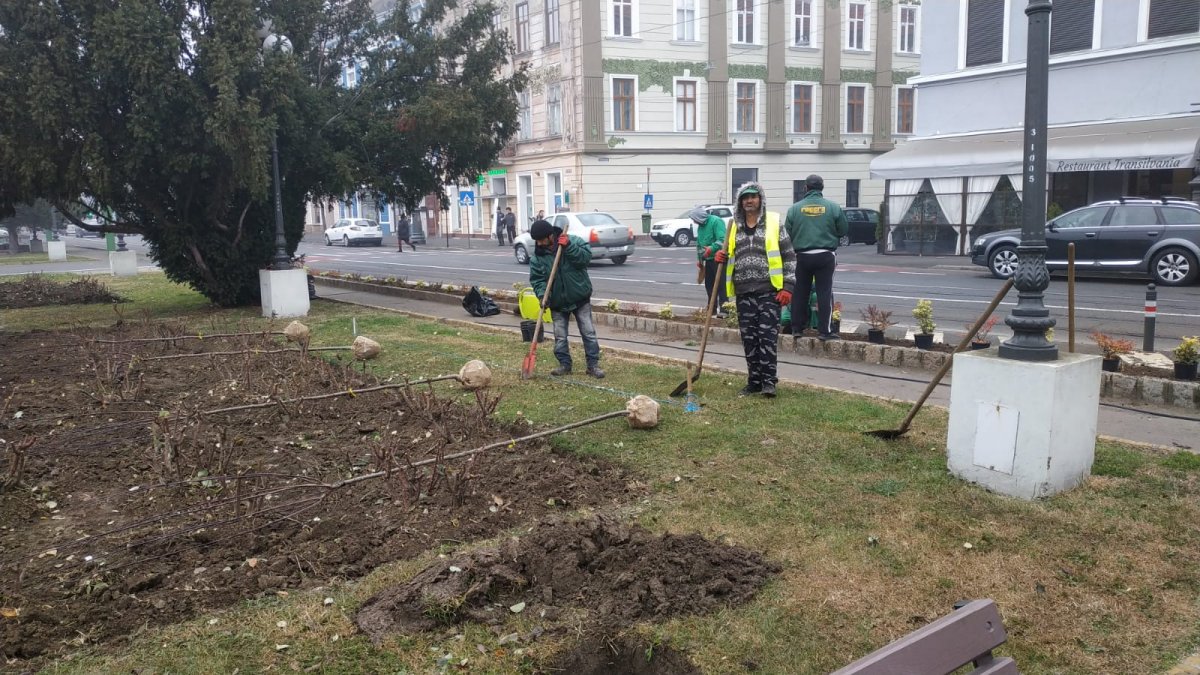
[316,276,1200,411]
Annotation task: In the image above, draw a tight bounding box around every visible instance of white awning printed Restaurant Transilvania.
[871,115,1200,179]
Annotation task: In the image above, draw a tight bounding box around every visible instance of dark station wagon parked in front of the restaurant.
[971,197,1200,286]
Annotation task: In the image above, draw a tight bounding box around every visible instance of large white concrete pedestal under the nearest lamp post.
[946,350,1100,500]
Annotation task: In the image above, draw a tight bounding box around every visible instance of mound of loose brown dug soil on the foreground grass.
[355,518,779,641]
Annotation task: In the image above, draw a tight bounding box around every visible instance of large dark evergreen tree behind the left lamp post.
[0,0,523,305]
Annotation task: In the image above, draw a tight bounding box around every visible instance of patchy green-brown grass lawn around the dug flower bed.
[4,274,1200,674]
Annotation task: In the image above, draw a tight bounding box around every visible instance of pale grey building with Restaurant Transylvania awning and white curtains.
[871,0,1200,253]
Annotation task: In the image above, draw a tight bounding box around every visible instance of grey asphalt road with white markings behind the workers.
[11,230,1200,351]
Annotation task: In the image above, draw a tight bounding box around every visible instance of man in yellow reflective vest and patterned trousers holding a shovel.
[715,183,796,399]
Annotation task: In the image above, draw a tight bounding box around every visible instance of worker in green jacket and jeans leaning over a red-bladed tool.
[529,220,604,378]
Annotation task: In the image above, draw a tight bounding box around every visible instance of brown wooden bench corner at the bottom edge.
[834,599,1018,675]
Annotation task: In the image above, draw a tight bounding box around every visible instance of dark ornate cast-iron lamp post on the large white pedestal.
[1000,0,1058,362]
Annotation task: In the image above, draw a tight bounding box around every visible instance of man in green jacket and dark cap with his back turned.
[784,174,850,340]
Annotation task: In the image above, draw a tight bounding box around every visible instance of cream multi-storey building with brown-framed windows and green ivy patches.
[445,0,925,233]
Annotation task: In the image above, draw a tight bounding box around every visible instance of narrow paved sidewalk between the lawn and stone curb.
[317,280,1200,452]
